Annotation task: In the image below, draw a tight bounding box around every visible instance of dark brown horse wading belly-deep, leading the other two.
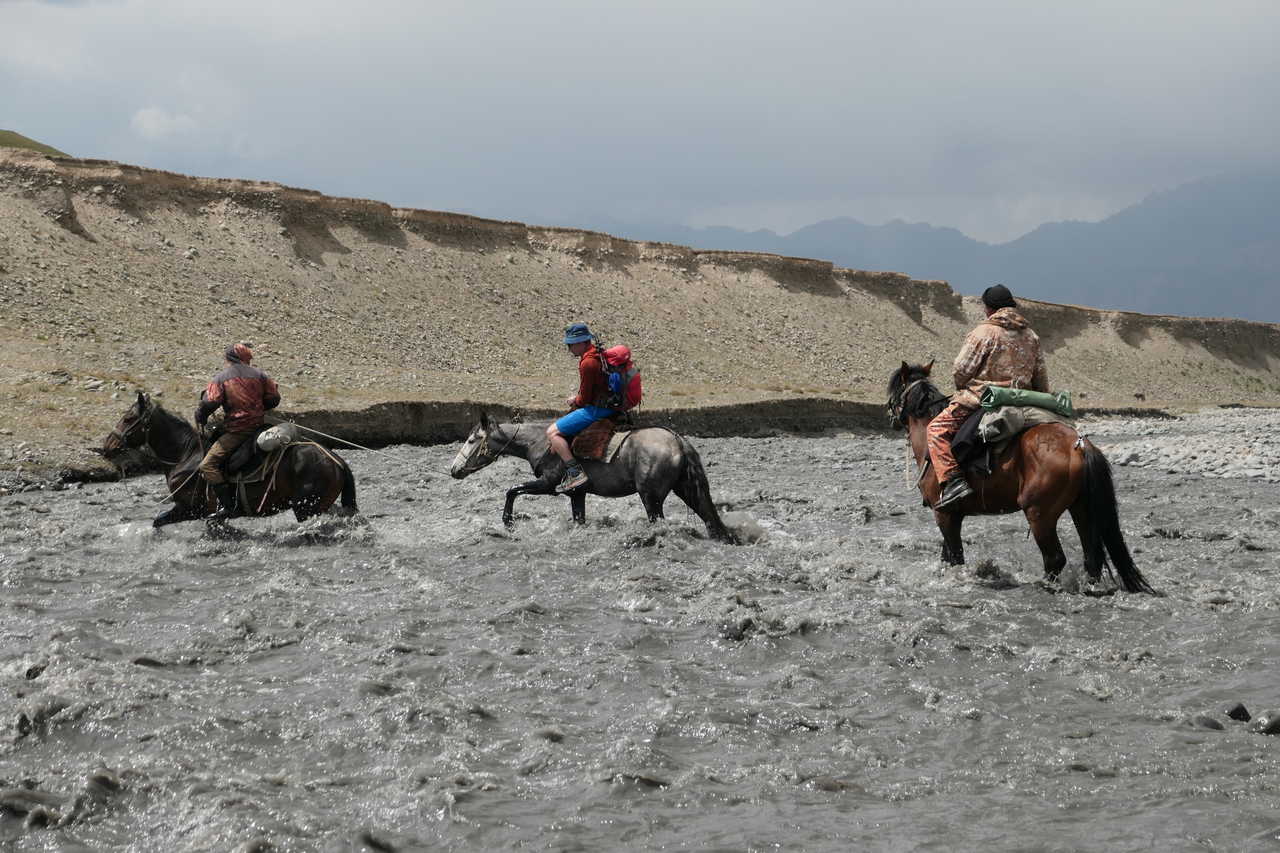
[101,391,357,528]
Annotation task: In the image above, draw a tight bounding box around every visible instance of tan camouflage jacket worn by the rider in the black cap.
[952,309,1048,409]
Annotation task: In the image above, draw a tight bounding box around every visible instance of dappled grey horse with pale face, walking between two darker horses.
[449,414,737,543]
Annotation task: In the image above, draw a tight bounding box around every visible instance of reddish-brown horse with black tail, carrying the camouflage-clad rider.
[888,361,1156,593]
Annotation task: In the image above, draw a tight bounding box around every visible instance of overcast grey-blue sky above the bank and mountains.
[0,0,1280,242]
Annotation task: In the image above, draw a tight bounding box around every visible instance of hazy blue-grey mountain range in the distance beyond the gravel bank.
[589,172,1280,323]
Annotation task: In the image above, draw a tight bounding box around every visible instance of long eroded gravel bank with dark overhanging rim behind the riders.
[0,150,1280,479]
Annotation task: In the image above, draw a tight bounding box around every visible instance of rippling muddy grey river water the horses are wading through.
[0,411,1280,850]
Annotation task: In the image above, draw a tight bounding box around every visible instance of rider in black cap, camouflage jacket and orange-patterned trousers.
[928,284,1048,510]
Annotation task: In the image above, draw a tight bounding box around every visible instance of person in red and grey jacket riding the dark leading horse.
[196,343,280,519]
